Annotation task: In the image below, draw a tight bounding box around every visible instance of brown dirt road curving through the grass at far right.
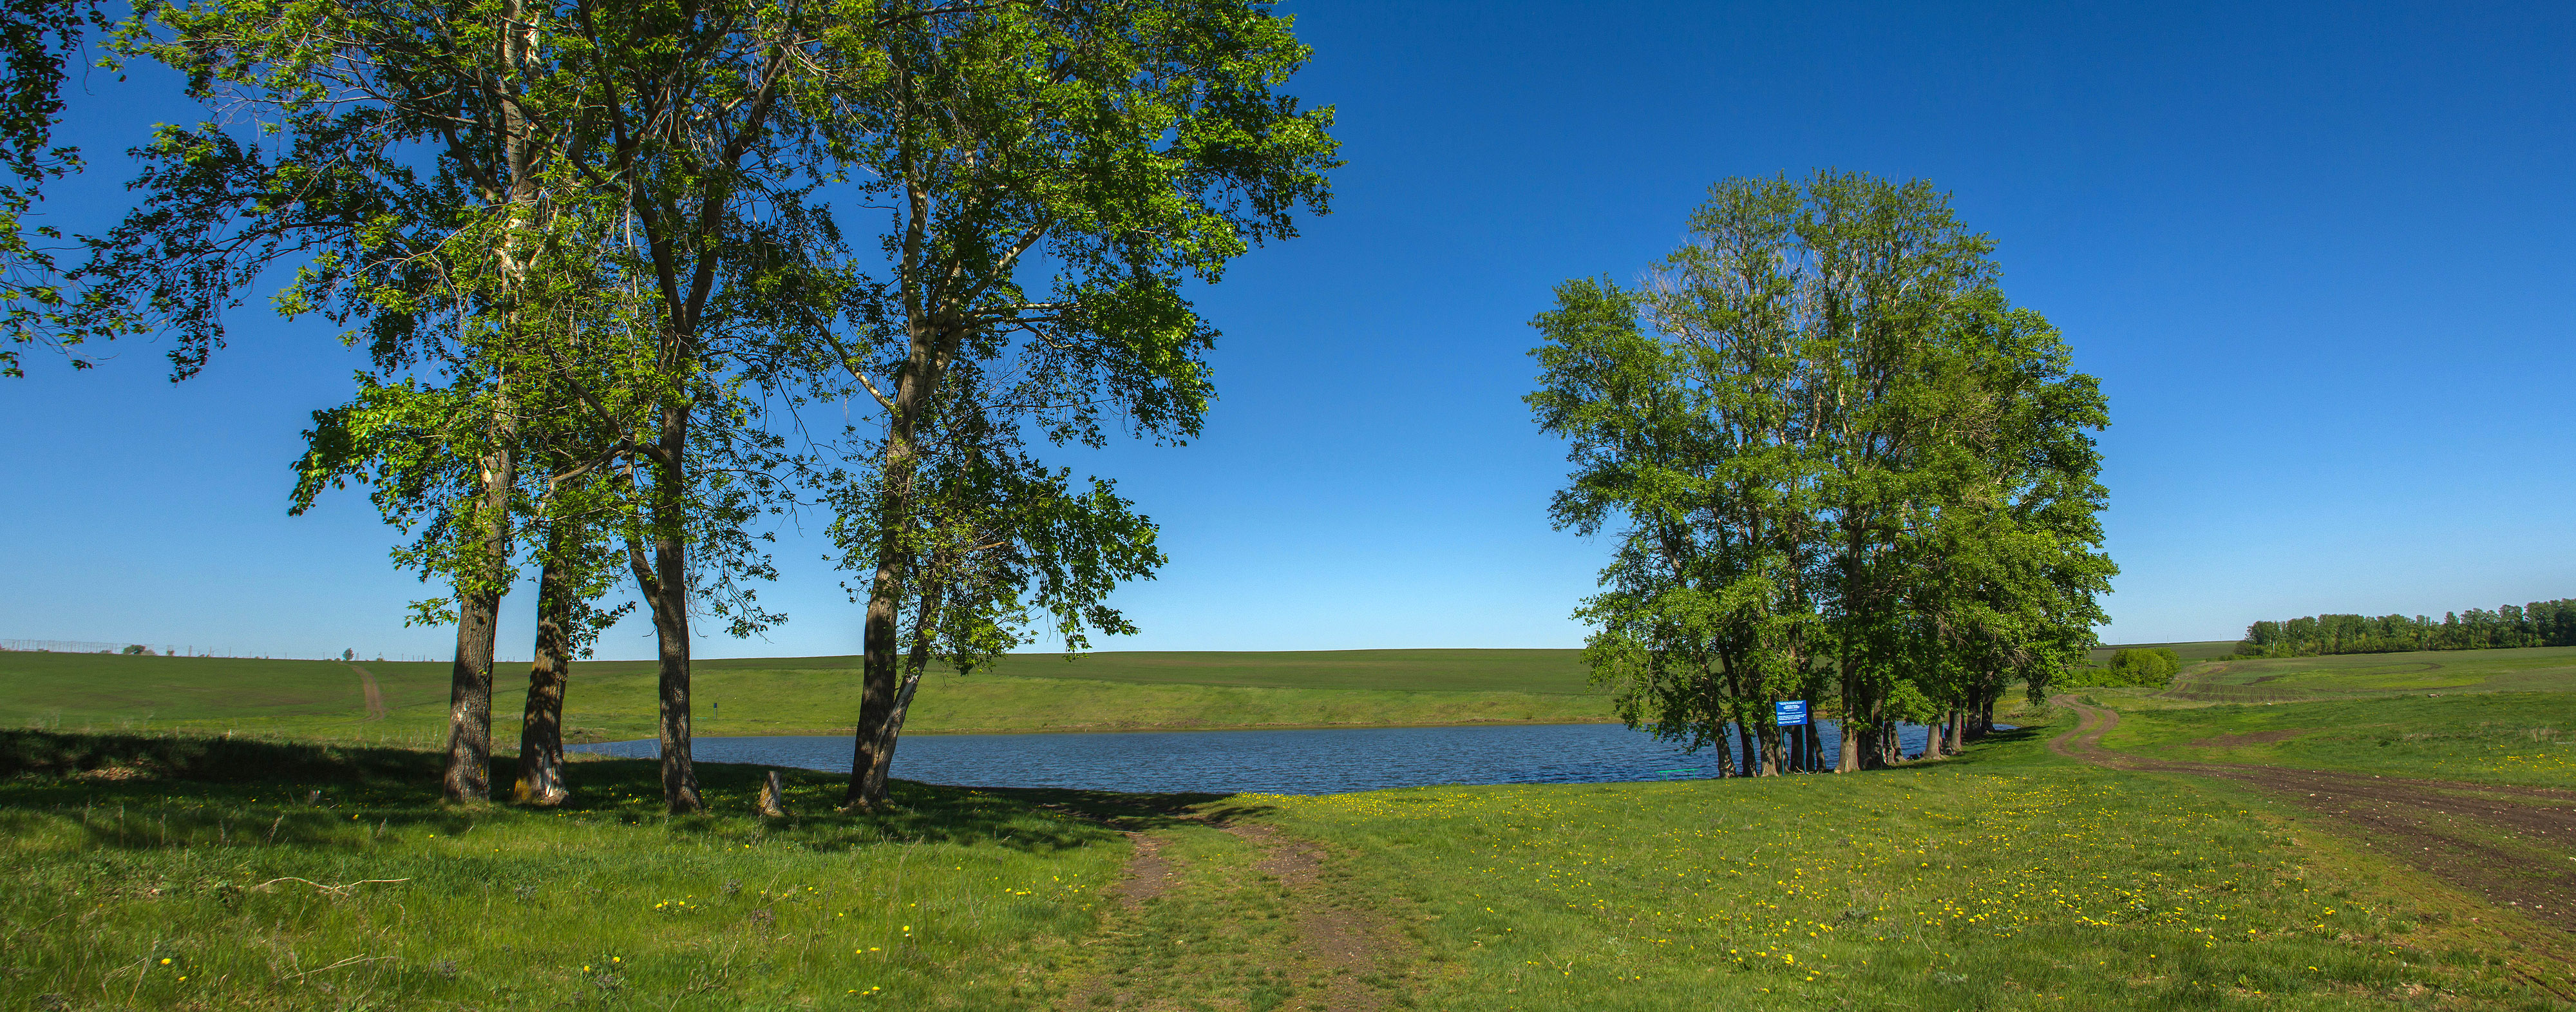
[2048,695,2576,997]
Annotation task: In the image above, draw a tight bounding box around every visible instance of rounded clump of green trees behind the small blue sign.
[1528,173,2115,772]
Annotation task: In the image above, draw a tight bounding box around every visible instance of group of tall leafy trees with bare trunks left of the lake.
[13,0,1337,811]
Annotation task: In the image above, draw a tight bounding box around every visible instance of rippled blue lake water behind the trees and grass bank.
[572,721,1924,793]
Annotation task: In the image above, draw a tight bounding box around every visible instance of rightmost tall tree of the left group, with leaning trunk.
[827,0,1334,806]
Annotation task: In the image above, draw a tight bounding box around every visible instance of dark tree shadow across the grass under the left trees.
[0,731,1267,852]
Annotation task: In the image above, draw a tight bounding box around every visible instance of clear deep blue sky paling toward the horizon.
[0,0,2576,659]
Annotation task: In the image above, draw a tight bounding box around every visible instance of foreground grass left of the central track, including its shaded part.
[0,731,1149,1009]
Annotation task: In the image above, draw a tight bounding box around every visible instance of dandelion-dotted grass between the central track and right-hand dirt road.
[1236,700,2553,1009]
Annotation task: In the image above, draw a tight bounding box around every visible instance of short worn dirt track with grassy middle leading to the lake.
[1059,814,1412,1012]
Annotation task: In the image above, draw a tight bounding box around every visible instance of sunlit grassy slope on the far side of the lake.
[0,649,1610,744]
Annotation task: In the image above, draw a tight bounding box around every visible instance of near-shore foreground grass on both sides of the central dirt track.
[0,664,2558,1009]
